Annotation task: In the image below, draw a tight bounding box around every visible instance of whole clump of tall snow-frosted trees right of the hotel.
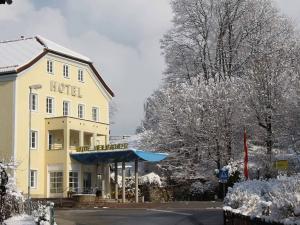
[139,0,300,178]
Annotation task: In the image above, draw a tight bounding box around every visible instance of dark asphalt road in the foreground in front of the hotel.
[55,208,223,225]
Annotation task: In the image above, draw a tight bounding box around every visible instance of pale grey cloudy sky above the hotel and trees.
[0,0,300,135]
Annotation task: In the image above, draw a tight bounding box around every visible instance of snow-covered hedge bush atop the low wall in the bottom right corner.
[224,176,300,224]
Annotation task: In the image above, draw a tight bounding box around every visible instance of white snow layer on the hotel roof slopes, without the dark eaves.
[0,36,91,73]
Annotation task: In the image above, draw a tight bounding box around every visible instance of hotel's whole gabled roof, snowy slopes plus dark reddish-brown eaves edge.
[0,36,114,97]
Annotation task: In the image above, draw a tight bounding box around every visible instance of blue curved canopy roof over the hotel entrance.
[70,149,168,165]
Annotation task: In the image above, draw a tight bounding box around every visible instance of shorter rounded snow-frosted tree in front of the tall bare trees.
[142,78,239,178]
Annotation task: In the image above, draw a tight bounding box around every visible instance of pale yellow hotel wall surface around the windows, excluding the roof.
[0,52,112,197]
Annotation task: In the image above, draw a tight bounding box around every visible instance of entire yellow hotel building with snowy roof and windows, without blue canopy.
[0,36,114,197]
